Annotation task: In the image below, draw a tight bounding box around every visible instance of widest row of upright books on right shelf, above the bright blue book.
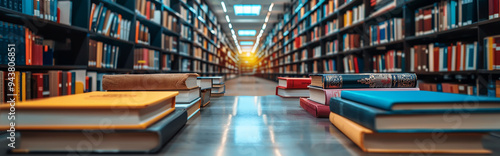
[410,42,478,72]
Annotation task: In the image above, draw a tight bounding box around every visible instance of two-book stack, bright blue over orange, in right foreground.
[330,91,500,154]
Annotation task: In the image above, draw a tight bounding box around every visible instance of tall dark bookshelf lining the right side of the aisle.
[256,0,500,95]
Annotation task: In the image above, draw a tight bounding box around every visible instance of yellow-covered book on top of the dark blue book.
[0,91,178,130]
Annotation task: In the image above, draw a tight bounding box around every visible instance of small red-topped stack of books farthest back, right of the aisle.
[276,77,311,98]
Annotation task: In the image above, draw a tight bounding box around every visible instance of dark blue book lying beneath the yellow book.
[13,109,187,153]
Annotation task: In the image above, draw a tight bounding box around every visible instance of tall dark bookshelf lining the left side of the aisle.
[0,0,238,78]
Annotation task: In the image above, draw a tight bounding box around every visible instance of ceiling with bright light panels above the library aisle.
[206,0,290,52]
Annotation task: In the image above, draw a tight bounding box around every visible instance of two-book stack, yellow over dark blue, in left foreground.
[0,91,187,153]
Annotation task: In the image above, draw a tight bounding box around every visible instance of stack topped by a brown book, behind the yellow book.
[102,73,201,120]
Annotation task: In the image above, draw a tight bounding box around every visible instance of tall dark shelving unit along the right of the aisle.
[256,0,500,95]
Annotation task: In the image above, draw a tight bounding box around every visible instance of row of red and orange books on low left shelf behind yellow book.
[0,70,111,103]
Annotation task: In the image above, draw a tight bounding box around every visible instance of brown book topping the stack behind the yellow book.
[102,73,198,91]
